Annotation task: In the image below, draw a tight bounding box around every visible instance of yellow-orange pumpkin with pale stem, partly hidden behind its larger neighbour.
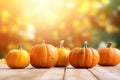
[55,40,70,67]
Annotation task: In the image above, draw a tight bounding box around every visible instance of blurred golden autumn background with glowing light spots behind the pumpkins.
[0,0,120,58]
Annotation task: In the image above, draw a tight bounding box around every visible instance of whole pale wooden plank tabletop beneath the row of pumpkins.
[0,64,120,80]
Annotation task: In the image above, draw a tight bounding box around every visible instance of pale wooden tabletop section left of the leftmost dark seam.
[0,65,65,80]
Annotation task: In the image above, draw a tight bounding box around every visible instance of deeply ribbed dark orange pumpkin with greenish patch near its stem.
[69,41,100,68]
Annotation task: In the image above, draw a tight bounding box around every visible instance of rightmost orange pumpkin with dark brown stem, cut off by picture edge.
[98,42,120,66]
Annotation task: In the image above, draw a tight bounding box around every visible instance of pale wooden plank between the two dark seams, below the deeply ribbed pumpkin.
[64,66,97,80]
